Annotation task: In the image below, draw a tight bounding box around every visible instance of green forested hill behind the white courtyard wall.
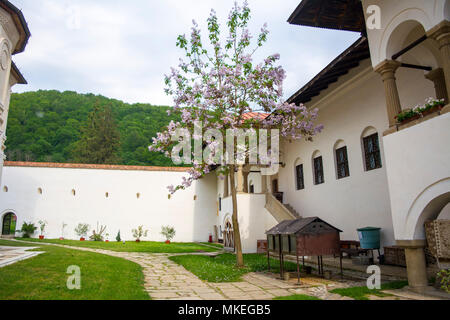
[6,91,178,166]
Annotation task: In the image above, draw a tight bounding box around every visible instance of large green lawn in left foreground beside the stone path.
[0,240,150,300]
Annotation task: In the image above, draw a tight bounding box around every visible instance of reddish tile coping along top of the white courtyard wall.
[4,161,189,172]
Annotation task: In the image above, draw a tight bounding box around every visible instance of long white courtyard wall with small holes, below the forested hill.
[0,166,217,242]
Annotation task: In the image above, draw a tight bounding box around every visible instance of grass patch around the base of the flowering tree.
[169,253,297,282]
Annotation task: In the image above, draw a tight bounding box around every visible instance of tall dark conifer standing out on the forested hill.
[72,106,120,164]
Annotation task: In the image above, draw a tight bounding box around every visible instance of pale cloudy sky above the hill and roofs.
[11,0,359,105]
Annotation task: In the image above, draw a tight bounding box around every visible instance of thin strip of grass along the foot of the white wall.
[18,239,218,253]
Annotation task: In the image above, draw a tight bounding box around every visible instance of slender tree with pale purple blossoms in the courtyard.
[149,2,322,266]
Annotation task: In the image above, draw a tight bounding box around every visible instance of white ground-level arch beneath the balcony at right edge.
[403,177,450,240]
